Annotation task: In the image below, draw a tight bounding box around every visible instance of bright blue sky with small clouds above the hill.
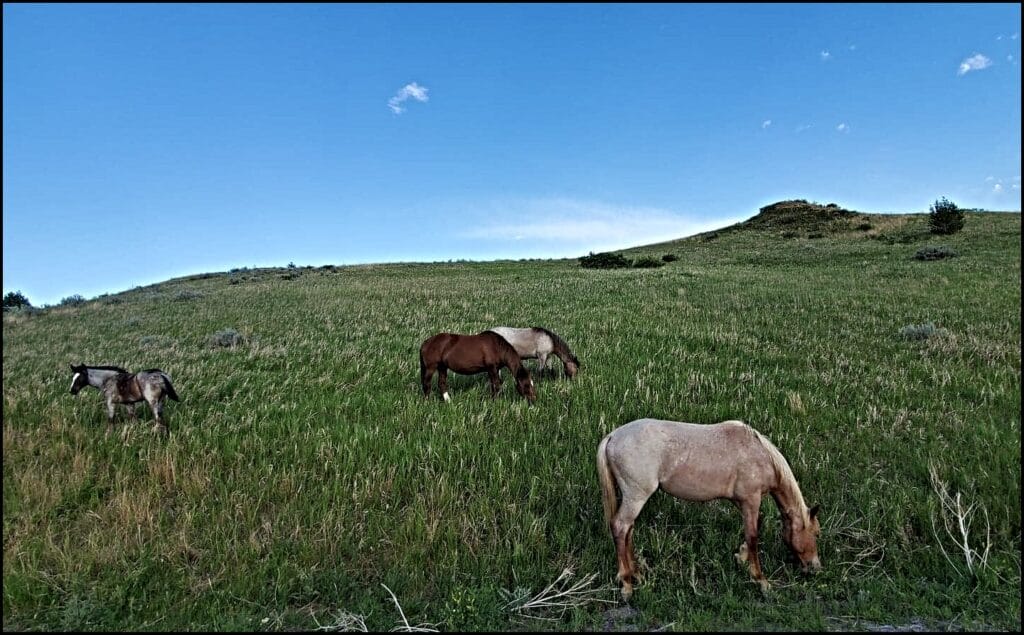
[3,4,1021,305]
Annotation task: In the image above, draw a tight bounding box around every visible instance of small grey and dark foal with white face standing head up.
[71,364,181,434]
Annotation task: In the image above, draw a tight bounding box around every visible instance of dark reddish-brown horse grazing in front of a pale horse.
[420,331,537,404]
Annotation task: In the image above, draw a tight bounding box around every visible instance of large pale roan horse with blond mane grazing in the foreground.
[597,419,821,600]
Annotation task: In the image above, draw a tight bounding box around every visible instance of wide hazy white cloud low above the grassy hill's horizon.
[461,198,742,251]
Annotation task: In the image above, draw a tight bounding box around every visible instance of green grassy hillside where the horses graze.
[3,204,1021,631]
